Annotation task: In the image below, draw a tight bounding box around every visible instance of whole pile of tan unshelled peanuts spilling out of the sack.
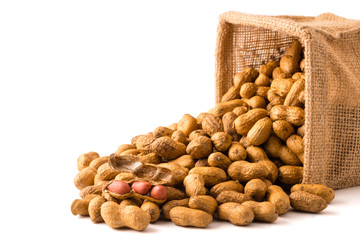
[71,40,335,231]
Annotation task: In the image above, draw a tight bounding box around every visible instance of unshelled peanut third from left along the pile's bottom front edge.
[217,202,255,226]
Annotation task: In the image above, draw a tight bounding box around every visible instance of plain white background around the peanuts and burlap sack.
[0,0,360,239]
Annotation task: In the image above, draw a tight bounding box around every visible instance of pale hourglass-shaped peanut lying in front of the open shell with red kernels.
[101,202,150,231]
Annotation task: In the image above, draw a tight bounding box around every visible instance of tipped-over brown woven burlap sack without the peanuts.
[216,12,360,188]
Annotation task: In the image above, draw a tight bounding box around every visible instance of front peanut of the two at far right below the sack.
[289,191,327,213]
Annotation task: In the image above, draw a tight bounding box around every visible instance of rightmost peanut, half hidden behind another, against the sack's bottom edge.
[290,184,335,203]
